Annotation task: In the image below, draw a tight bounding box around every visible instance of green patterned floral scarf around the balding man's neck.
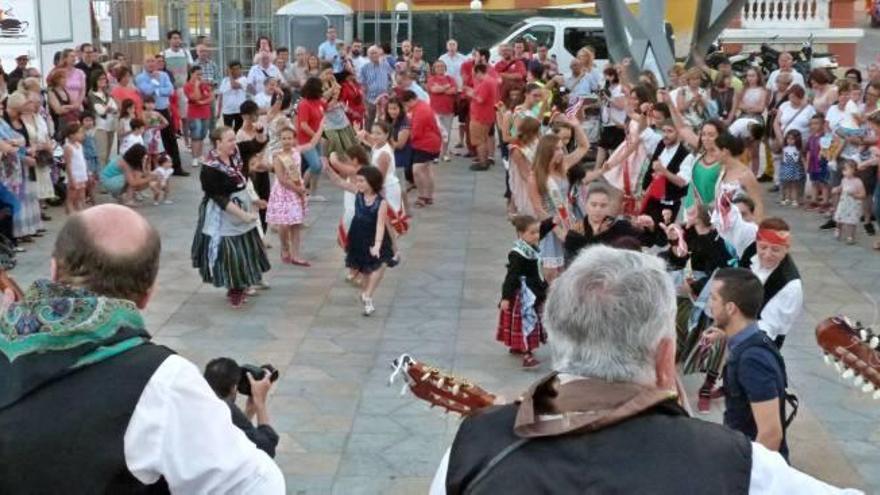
[0,280,150,409]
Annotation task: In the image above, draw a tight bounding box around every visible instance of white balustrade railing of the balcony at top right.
[742,0,831,29]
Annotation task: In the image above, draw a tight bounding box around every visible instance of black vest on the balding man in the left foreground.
[0,343,172,495]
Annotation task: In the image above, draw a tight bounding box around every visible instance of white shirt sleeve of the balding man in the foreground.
[124,355,285,495]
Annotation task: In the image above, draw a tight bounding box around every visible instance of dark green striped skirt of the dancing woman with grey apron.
[190,201,270,289]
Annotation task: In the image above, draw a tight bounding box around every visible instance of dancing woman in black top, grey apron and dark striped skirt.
[191,127,269,308]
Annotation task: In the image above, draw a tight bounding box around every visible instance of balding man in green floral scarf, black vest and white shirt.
[0,205,284,494]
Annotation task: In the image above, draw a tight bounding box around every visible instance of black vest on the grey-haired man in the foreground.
[446,401,752,495]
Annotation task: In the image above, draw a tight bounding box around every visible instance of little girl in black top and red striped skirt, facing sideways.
[495,215,553,368]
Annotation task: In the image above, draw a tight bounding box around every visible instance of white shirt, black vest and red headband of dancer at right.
[712,201,804,348]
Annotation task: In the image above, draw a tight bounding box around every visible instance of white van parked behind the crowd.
[489,17,608,74]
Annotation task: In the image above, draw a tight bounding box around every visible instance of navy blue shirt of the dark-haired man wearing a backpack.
[724,323,788,460]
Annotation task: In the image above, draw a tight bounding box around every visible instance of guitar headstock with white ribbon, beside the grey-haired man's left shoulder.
[389,354,495,416]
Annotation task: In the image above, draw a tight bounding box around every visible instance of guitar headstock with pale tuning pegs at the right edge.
[816,316,880,399]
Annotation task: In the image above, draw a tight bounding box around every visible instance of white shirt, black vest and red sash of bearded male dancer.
[641,129,694,223]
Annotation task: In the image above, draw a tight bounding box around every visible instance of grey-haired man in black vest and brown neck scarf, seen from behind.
[430,246,860,495]
